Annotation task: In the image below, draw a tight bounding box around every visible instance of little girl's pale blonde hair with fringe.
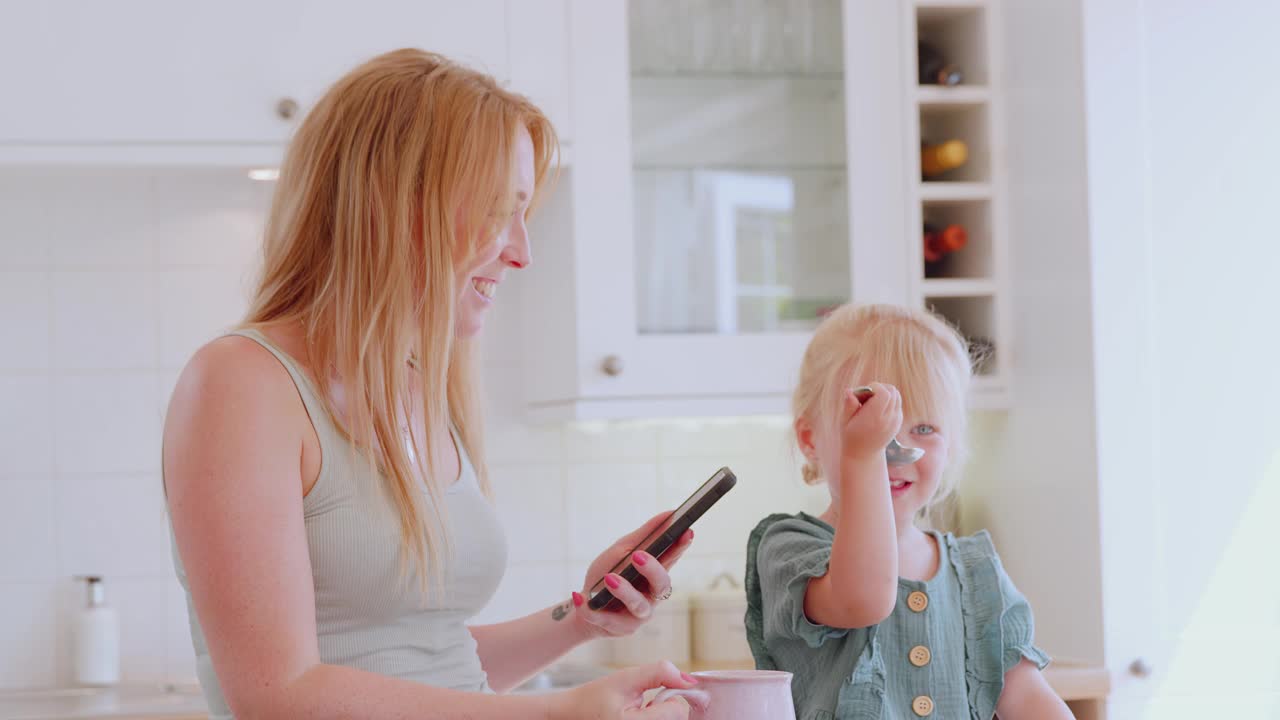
[791,305,973,506]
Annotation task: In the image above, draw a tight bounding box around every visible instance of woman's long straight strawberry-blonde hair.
[244,49,558,591]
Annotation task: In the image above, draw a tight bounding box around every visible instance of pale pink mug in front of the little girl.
[653,670,796,720]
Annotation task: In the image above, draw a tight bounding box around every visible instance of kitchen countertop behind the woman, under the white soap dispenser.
[0,685,207,720]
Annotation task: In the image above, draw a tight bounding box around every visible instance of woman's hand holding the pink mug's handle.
[552,661,698,720]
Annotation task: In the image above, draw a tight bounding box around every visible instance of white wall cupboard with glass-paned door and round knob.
[525,0,919,419]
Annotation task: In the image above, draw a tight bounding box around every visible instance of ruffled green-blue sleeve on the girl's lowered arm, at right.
[946,530,1050,719]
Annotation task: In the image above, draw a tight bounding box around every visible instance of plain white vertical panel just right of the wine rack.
[961,0,1102,664]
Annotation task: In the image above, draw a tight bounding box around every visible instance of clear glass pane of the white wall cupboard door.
[628,0,850,336]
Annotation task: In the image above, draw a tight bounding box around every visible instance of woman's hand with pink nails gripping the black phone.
[573,511,694,637]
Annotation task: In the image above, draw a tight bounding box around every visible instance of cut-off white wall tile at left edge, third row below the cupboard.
[0,374,54,475]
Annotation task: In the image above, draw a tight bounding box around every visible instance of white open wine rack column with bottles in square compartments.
[902,0,1014,397]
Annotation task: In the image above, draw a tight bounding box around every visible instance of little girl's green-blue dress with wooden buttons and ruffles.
[746,512,1048,720]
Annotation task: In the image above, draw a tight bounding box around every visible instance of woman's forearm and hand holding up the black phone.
[471,512,694,692]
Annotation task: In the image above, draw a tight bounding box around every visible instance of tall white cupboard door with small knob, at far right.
[1083,0,1280,720]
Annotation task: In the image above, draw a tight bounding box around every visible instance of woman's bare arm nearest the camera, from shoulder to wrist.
[164,338,563,720]
